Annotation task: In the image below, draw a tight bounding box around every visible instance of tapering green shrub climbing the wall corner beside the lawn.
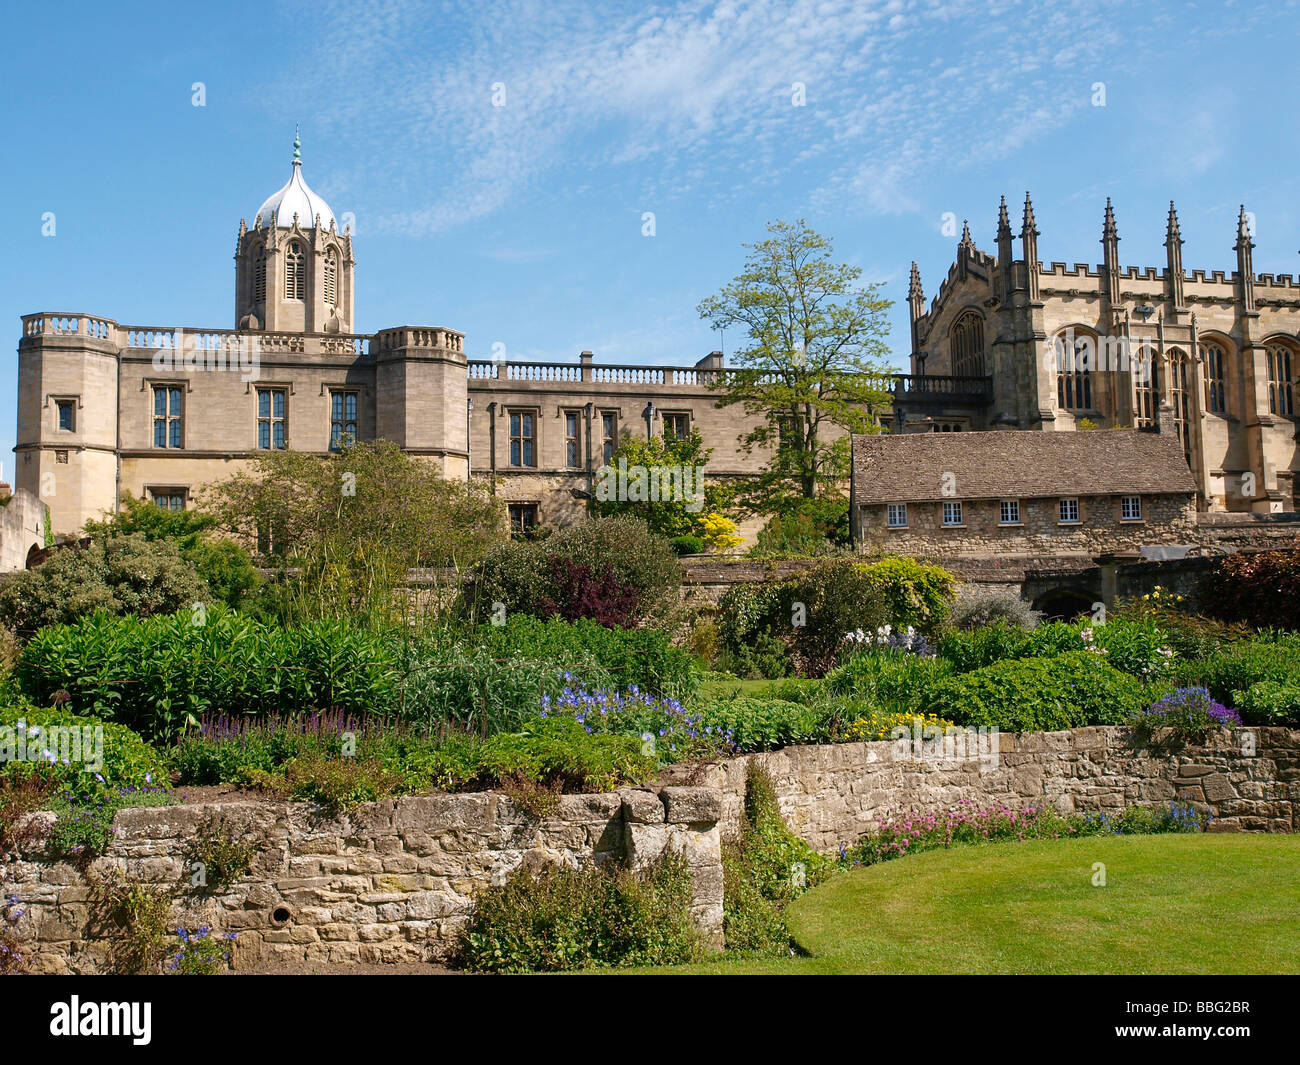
[723,762,829,954]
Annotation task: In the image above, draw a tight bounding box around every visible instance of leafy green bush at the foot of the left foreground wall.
[456,850,701,973]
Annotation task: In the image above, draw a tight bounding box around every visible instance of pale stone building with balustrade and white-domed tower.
[14,140,780,537]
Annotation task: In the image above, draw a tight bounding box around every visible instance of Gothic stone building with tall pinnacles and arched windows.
[894,195,1300,514]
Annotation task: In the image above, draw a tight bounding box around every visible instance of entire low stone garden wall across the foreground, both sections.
[0,728,1300,973]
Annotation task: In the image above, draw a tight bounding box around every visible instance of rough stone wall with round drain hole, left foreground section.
[0,787,723,973]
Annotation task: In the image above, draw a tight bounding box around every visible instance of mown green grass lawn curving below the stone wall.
[634,834,1300,974]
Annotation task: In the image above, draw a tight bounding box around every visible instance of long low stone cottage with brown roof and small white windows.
[850,408,1196,559]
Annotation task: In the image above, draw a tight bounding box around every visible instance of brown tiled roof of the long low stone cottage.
[853,429,1196,503]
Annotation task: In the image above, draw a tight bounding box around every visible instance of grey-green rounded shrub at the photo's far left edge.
[0,533,211,635]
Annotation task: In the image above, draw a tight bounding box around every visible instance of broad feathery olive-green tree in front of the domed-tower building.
[209,441,506,620]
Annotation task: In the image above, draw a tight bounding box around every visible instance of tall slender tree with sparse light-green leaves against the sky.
[697,218,892,514]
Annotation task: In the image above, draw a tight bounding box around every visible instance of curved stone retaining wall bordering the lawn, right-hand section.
[660,727,1300,850]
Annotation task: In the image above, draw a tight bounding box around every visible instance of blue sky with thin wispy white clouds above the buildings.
[0,0,1300,476]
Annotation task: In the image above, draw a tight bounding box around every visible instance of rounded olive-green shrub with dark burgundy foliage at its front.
[460,516,681,625]
